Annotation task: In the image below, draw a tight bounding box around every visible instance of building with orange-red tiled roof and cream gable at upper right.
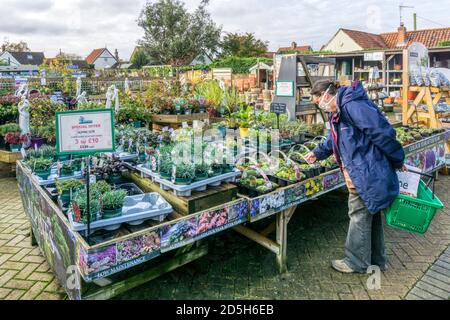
[322,24,450,95]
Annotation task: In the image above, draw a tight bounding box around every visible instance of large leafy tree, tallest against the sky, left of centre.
[138,0,222,66]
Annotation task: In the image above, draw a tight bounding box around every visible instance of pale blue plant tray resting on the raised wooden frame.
[155,170,241,197]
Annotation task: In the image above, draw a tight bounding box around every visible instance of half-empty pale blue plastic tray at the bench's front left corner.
[68,192,173,233]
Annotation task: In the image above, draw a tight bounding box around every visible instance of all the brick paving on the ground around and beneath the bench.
[0,177,450,300]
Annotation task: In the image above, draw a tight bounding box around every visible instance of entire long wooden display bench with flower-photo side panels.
[17,132,450,299]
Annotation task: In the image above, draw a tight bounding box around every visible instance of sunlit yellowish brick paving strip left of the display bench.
[0,179,65,300]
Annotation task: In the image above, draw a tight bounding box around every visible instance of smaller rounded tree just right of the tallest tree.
[222,33,269,57]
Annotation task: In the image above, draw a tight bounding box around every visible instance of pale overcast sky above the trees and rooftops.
[0,0,450,60]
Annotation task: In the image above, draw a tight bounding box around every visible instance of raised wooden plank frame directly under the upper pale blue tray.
[127,173,238,215]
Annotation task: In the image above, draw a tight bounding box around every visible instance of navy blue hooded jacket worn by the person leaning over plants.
[314,82,405,214]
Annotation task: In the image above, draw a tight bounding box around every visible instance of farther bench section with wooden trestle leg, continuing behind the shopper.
[235,131,450,273]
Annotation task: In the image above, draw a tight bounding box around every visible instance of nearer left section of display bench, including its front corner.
[17,161,248,299]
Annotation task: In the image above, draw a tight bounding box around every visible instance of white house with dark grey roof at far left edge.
[0,51,45,76]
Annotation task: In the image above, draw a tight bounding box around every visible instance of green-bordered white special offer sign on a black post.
[56,109,115,155]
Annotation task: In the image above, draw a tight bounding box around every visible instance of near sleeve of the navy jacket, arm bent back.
[346,101,405,169]
